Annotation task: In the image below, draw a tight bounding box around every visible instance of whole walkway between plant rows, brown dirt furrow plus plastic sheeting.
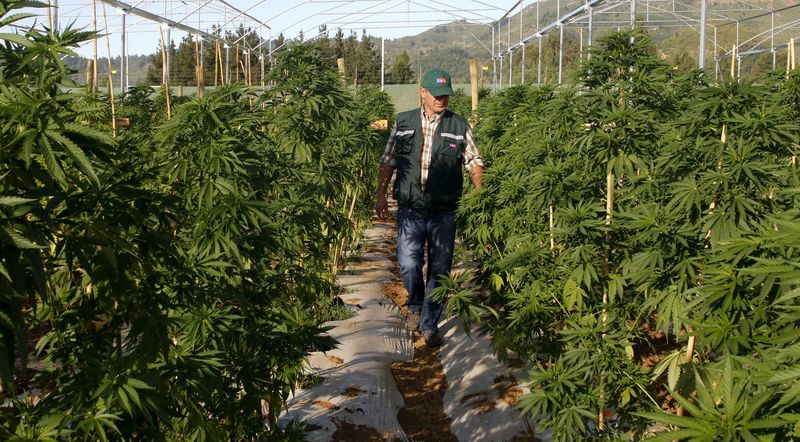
[281,214,535,442]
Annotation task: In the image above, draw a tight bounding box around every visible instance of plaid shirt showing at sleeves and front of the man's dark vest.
[381,108,483,189]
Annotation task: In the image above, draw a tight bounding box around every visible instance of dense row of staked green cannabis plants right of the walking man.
[443,31,800,441]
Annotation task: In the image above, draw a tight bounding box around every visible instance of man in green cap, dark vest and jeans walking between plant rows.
[375,68,483,347]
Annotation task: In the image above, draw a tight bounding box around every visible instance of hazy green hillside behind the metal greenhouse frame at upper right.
[376,0,800,83]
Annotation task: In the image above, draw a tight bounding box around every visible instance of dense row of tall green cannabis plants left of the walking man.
[0,1,391,440]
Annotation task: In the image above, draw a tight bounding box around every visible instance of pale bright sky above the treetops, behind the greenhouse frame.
[20,0,534,56]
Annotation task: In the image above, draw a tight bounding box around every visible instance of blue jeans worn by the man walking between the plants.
[397,207,456,332]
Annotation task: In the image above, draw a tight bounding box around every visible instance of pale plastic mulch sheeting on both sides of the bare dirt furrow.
[281,223,546,442]
